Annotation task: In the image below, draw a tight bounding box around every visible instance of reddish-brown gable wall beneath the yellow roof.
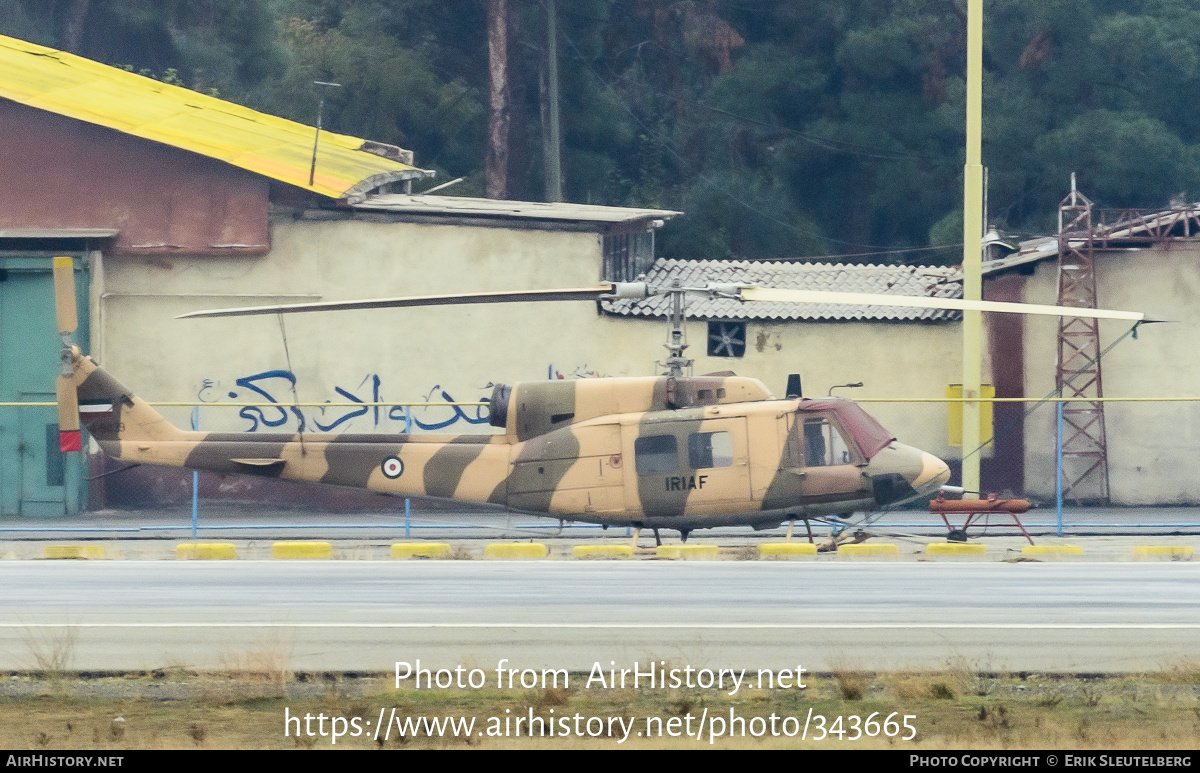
[0,100,269,254]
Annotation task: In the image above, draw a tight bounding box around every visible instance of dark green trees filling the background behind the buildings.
[0,0,1200,263]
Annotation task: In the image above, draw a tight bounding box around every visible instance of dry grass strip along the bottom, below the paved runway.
[0,672,1200,750]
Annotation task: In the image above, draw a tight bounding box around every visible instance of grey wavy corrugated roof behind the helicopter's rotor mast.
[604,258,962,322]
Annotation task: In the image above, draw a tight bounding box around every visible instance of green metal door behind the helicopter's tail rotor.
[0,252,88,517]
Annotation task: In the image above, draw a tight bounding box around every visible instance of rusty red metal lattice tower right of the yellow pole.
[1055,174,1109,504]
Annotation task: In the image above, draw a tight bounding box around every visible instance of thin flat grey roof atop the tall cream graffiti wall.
[355,193,680,223]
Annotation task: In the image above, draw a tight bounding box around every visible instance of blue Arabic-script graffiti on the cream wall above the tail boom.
[197,370,492,432]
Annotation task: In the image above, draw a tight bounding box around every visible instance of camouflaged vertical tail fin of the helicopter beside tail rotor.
[71,347,191,457]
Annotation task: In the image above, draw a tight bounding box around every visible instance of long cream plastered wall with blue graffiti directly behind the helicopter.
[94,218,960,480]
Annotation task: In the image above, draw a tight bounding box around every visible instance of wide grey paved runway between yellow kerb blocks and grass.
[0,561,1200,671]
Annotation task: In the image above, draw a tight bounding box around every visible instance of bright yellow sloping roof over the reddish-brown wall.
[0,36,432,200]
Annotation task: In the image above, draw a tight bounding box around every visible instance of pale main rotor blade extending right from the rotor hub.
[740,287,1146,322]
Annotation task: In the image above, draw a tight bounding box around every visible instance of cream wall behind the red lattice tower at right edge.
[1025,245,1200,505]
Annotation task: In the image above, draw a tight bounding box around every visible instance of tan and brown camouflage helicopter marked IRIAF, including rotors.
[54,258,1142,545]
